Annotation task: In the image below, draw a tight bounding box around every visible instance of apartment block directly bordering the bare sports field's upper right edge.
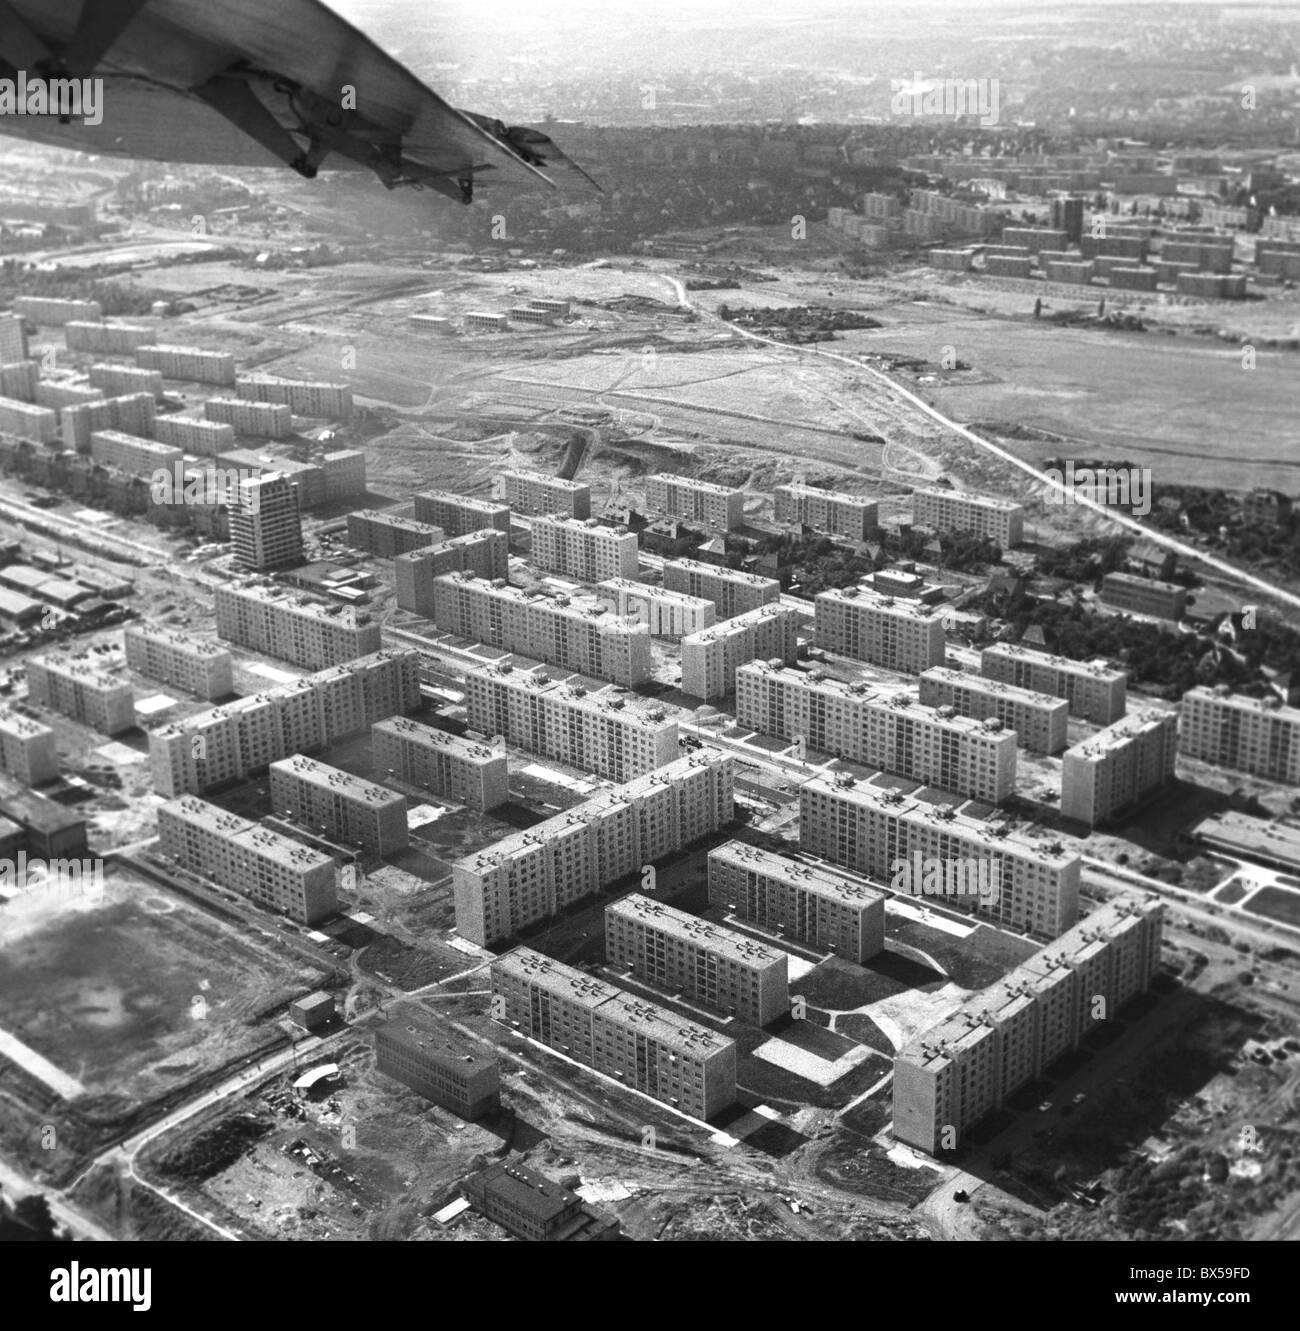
[158,795,338,925]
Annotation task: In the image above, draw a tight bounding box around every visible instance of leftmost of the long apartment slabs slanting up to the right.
[149,651,420,796]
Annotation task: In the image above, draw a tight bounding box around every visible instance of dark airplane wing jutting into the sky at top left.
[0,0,599,204]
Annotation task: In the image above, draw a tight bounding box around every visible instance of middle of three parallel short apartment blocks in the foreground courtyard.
[605,892,790,1026]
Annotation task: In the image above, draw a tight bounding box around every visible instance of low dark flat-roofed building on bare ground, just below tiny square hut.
[375,1004,500,1121]
